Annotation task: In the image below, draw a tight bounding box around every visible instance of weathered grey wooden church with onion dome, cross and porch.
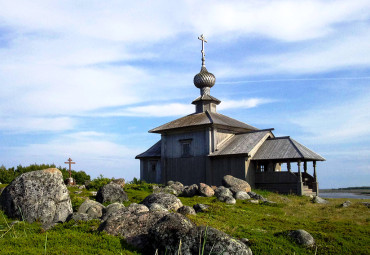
[136,35,325,195]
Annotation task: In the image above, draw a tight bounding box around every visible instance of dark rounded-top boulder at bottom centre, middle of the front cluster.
[149,213,198,255]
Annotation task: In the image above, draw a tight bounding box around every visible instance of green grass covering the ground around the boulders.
[0,184,370,254]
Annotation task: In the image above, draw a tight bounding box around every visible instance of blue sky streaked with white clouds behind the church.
[0,0,370,188]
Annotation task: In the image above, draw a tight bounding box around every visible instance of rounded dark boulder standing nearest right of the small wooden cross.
[96,183,128,203]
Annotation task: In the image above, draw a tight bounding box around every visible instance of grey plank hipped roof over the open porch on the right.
[252,136,325,161]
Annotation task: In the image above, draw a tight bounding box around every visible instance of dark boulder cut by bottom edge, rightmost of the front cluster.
[198,227,253,255]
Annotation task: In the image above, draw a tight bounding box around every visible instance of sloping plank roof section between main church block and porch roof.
[210,129,272,157]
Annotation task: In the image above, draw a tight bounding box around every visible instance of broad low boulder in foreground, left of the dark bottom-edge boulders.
[99,204,168,251]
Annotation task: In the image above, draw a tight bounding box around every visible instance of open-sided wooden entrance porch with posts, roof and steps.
[252,137,325,195]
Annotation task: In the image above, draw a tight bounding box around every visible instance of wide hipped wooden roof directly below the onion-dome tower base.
[149,111,258,133]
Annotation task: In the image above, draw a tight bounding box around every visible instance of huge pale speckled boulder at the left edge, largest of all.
[0,168,73,226]
